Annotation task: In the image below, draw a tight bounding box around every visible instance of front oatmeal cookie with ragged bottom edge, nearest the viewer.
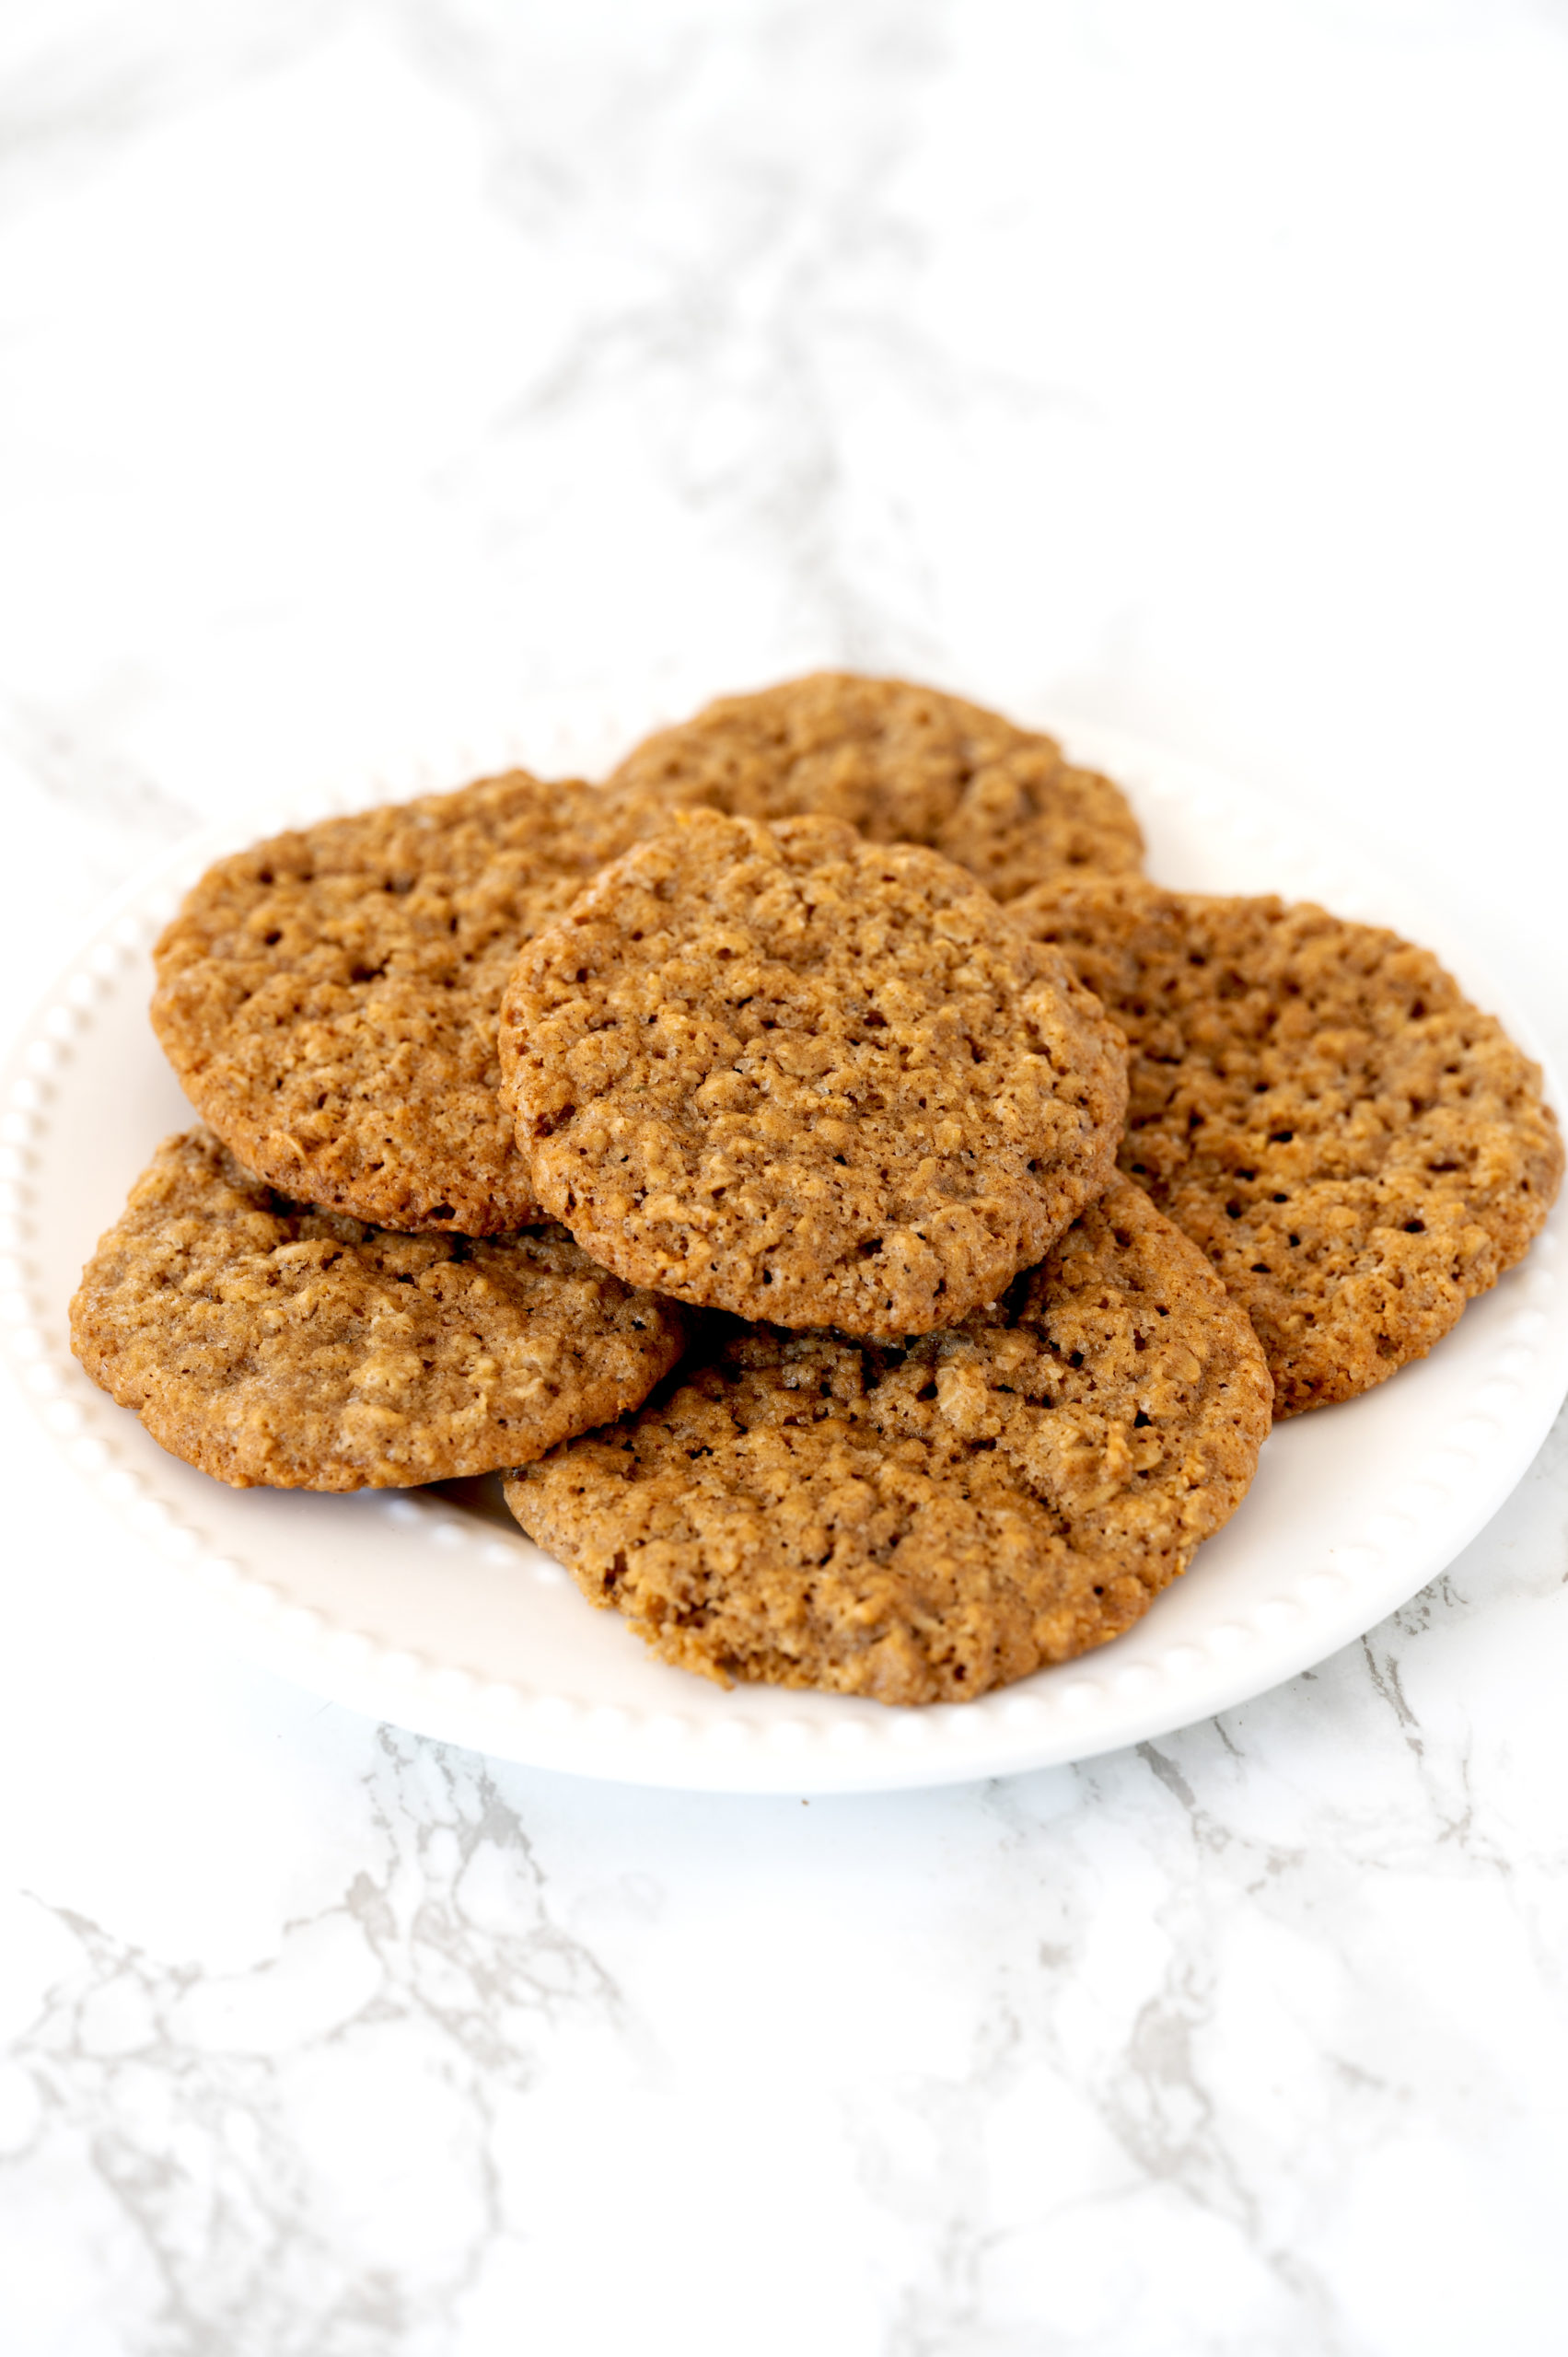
[507,1183,1271,1701]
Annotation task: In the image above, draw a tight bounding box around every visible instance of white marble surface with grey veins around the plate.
[0,0,1568,2357]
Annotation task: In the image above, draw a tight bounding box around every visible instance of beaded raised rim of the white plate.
[0,716,1568,1794]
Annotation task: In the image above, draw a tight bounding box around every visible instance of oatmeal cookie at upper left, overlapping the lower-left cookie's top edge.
[153,771,625,1235]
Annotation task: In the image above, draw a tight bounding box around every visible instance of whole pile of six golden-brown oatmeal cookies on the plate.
[73,674,1563,1701]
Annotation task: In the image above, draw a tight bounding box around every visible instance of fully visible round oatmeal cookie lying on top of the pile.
[500,811,1125,1334]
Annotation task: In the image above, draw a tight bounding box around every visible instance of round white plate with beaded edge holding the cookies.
[0,726,1568,1794]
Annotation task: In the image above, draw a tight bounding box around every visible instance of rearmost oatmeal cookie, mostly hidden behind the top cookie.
[606,672,1144,900]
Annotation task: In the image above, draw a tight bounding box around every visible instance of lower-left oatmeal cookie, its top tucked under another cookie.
[71,1129,684,1490]
